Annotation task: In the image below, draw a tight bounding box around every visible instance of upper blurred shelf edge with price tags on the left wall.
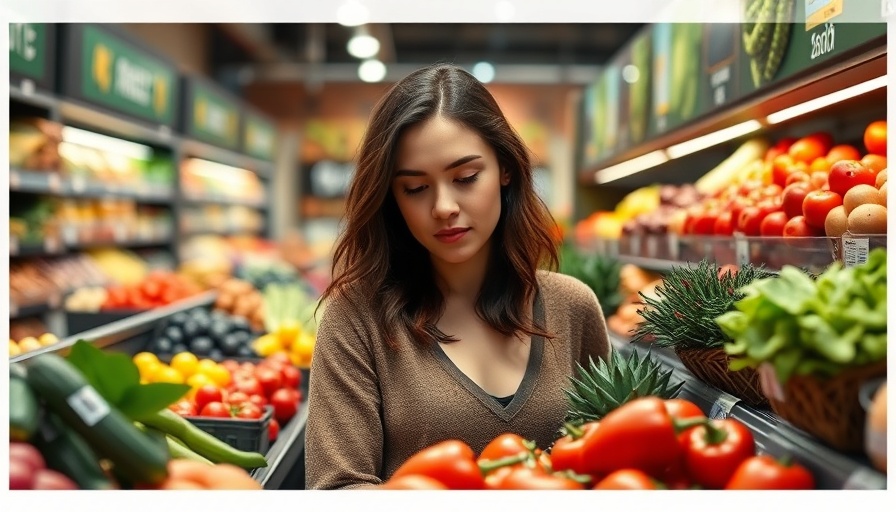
[9,168,174,204]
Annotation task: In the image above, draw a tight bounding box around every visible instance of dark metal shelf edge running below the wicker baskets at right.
[610,333,887,490]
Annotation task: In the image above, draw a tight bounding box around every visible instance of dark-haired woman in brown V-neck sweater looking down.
[305,65,609,489]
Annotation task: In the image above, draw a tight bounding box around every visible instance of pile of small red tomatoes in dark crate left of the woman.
[170,355,303,441]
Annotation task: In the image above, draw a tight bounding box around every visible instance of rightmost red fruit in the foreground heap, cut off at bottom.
[725,455,815,490]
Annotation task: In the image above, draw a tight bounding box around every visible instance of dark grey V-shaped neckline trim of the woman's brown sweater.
[433,290,544,421]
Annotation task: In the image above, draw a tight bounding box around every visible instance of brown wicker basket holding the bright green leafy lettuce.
[768,361,887,453]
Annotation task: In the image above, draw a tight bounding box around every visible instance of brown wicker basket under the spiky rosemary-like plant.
[675,347,769,407]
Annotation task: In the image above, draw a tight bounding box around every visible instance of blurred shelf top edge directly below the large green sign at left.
[59,99,180,147]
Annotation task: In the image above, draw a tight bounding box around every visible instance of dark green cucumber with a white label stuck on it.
[25,353,169,485]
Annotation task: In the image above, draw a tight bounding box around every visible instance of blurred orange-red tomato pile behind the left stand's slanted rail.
[101,270,202,310]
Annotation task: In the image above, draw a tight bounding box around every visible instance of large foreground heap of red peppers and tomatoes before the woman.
[379,397,815,490]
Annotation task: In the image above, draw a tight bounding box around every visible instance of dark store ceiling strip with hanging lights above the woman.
[213,23,644,84]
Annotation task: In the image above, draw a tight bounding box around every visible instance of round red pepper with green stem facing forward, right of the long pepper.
[679,419,756,489]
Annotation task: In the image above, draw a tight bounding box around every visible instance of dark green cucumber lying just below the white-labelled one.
[34,412,118,490]
